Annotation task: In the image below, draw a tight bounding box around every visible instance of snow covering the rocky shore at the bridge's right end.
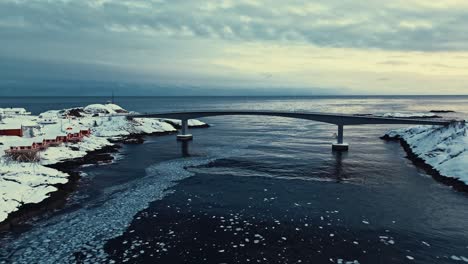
[386,122,468,184]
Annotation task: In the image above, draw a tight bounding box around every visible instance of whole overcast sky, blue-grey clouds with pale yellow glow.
[0,0,468,95]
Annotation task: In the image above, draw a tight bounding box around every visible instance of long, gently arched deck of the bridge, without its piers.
[129,110,452,125]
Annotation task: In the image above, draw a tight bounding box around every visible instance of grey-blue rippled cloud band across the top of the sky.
[0,0,468,51]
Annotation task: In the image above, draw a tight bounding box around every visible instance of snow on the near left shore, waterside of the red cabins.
[0,135,111,222]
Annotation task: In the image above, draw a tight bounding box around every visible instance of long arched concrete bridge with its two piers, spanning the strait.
[128,110,453,150]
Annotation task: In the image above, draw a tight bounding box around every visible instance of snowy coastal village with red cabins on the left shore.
[0,104,122,162]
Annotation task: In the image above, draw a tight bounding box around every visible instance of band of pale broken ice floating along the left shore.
[0,148,245,263]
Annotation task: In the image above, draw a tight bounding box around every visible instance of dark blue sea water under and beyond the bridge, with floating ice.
[0,97,468,263]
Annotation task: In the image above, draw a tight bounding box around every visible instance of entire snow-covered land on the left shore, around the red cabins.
[0,104,205,223]
